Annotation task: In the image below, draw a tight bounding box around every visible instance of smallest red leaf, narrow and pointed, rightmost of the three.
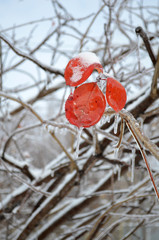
[106,78,127,112]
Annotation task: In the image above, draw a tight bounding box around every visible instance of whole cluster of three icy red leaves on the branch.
[64,52,126,128]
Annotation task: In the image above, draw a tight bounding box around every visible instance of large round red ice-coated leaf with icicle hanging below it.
[65,83,106,128]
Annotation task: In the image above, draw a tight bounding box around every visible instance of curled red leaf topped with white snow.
[64,52,103,86]
